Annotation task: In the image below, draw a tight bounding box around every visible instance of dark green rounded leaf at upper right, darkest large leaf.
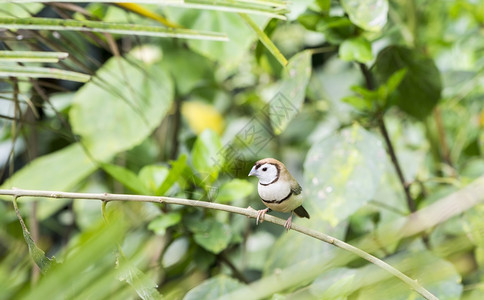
[372,46,442,119]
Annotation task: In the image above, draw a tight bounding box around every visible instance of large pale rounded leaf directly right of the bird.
[304,125,386,226]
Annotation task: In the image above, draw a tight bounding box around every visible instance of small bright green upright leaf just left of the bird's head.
[191,129,223,186]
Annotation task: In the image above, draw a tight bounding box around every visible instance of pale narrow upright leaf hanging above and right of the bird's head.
[269,50,311,135]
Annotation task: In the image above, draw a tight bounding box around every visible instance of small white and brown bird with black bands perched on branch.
[249,158,309,230]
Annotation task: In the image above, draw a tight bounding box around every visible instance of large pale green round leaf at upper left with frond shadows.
[69,58,173,160]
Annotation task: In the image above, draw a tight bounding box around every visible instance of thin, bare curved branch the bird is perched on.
[0,189,438,299]
